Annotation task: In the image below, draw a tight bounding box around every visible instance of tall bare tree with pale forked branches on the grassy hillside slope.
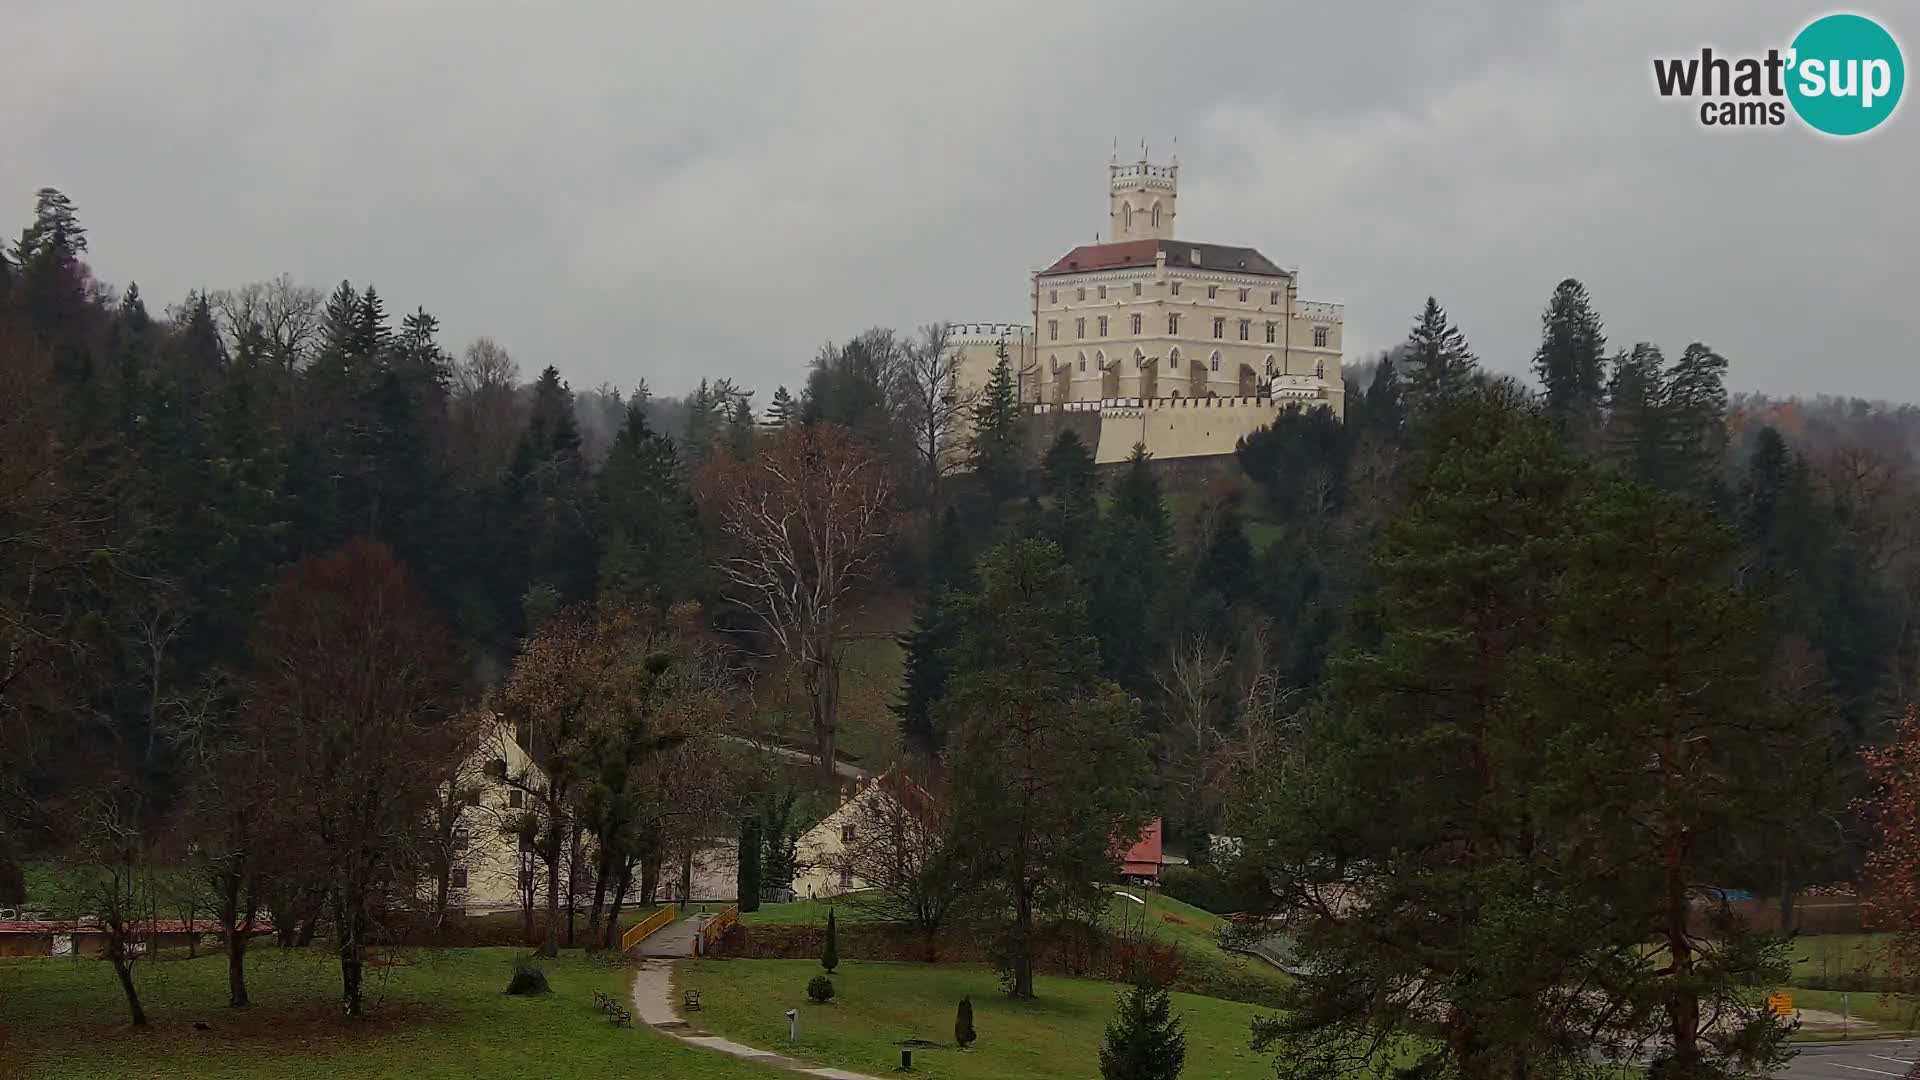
[701,423,893,784]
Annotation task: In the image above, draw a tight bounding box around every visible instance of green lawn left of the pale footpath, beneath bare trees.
[0,947,780,1080]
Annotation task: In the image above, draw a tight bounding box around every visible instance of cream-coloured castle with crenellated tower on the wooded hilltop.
[952,150,1346,461]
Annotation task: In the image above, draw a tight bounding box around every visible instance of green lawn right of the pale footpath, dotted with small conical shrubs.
[678,961,1273,1080]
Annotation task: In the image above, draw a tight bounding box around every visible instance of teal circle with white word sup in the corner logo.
[1788,15,1907,135]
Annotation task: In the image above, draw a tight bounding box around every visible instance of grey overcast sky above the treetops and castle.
[0,0,1920,402]
